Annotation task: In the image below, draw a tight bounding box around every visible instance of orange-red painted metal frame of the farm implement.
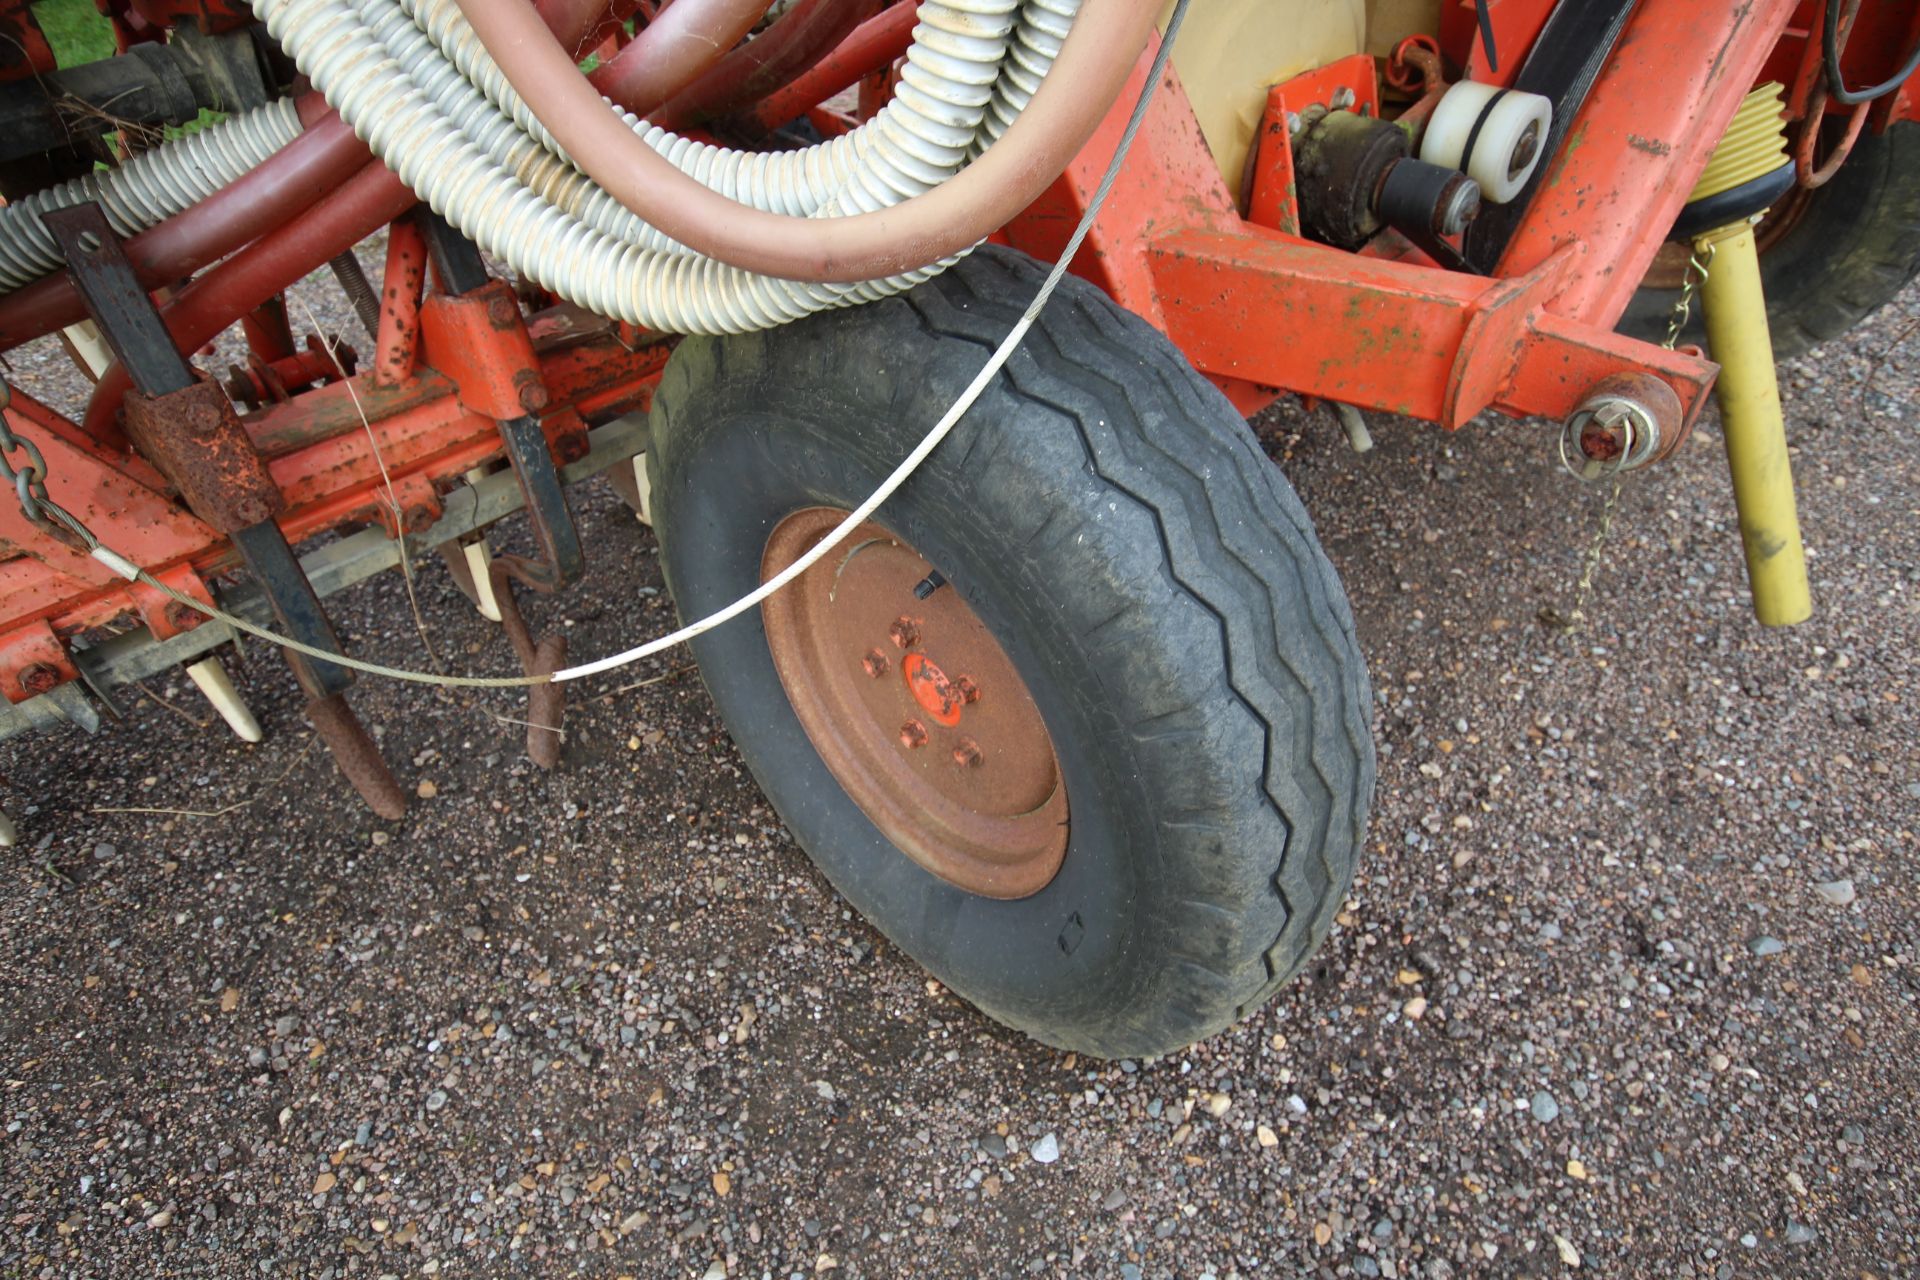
[0,0,1920,700]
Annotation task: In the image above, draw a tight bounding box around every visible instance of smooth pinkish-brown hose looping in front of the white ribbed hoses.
[459,0,1160,282]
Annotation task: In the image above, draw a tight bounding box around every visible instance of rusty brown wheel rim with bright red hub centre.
[760,507,1068,898]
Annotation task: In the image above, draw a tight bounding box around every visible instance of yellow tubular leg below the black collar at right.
[1697,225,1812,628]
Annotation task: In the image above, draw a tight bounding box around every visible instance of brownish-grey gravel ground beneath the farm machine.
[0,262,1920,1280]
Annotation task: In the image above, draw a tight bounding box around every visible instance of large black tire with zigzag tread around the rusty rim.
[649,248,1373,1057]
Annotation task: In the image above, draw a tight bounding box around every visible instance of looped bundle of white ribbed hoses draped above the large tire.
[255,0,1060,334]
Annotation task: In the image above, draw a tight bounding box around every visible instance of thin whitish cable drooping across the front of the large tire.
[86,0,1190,689]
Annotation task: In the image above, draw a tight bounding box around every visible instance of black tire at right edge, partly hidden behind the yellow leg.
[1619,121,1920,359]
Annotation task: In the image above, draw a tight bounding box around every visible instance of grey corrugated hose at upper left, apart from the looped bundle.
[0,98,300,294]
